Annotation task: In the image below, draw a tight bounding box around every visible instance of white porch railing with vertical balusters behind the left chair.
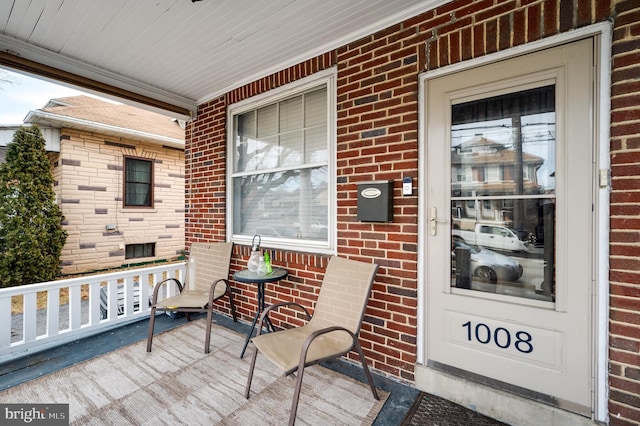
[0,263,185,363]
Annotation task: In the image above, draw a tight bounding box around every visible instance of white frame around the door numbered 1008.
[415,22,613,421]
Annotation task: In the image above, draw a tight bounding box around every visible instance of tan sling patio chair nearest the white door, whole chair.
[244,256,379,425]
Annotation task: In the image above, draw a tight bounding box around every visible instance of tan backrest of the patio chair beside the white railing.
[185,243,233,292]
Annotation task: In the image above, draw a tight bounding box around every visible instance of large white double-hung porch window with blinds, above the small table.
[228,69,335,251]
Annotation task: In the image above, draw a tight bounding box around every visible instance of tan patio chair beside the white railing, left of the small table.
[147,243,237,354]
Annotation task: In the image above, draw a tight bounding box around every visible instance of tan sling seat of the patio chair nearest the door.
[252,324,353,374]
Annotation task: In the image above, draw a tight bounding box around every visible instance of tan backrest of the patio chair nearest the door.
[311,256,378,335]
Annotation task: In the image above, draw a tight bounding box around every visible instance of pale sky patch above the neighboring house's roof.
[0,68,91,125]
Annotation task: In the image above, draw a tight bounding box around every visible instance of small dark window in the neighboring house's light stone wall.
[124,157,153,207]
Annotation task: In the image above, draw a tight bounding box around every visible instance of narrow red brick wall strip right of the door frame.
[609,1,640,425]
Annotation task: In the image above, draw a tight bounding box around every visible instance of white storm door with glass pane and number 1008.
[424,39,594,416]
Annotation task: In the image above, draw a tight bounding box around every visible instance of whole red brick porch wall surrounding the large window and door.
[187,0,640,425]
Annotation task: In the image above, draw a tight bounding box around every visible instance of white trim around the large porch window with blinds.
[226,67,337,254]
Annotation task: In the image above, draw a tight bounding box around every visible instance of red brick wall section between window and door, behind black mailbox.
[337,16,426,381]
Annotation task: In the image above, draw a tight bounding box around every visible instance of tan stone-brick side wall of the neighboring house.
[53,129,184,274]
